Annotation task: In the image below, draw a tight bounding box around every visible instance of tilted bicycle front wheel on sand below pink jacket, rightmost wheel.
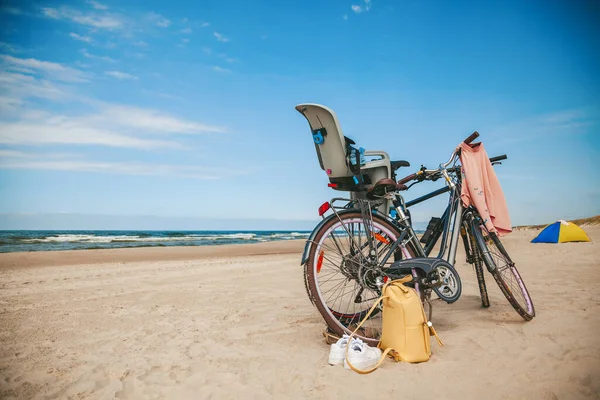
[471,222,535,321]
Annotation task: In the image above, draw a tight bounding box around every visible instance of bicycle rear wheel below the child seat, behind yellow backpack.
[305,211,416,346]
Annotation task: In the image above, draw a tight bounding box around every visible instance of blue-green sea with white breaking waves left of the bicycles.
[0,231,310,253]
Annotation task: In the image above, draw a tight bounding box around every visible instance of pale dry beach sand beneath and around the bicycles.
[0,228,600,399]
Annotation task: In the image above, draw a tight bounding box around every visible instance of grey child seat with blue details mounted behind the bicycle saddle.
[295,103,410,213]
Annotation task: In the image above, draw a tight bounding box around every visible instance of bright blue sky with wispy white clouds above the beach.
[0,0,600,229]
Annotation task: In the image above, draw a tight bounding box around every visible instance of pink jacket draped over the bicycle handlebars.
[458,142,512,236]
